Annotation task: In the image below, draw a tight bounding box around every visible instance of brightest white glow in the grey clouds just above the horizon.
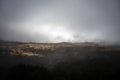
[35,24,74,42]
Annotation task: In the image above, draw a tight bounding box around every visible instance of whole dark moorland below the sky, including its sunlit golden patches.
[0,43,120,80]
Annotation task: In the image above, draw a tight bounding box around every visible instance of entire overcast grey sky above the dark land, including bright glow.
[0,0,120,42]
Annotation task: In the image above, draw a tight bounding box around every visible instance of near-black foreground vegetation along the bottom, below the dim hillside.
[0,60,120,80]
